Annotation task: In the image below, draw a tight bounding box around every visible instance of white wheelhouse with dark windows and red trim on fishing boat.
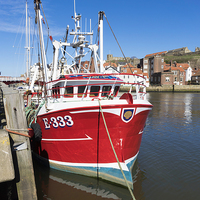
[48,74,123,100]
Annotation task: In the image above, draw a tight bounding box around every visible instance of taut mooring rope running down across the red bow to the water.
[98,100,136,200]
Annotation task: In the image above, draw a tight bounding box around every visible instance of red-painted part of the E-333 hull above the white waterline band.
[35,104,151,164]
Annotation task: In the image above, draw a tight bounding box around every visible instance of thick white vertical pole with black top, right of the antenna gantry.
[99,11,104,73]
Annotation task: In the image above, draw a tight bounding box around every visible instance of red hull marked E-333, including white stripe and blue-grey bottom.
[32,104,152,188]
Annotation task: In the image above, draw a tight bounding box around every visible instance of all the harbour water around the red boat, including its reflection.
[34,92,200,200]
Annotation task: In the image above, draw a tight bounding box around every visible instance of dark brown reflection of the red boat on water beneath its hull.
[34,159,145,200]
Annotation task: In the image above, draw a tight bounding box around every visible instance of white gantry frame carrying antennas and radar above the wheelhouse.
[52,0,99,75]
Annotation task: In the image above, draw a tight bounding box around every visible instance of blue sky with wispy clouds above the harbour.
[0,0,200,76]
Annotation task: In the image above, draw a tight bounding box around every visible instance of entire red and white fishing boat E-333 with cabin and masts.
[28,0,152,188]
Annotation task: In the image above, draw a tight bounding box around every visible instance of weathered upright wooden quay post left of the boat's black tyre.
[4,91,37,200]
